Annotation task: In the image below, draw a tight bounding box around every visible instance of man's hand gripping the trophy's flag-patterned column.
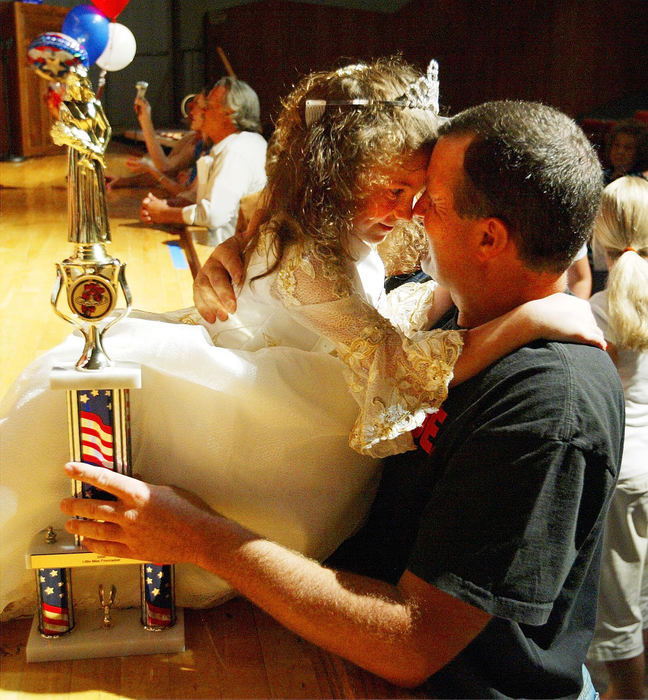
[61,462,217,564]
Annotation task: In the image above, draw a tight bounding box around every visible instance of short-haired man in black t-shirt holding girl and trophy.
[62,102,623,698]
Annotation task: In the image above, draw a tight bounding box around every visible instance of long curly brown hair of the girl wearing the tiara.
[252,57,438,282]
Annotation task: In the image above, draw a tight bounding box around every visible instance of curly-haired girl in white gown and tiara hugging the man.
[0,60,604,614]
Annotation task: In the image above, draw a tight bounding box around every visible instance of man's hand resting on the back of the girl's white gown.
[194,236,245,323]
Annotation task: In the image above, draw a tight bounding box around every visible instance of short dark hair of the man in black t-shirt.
[439,100,603,272]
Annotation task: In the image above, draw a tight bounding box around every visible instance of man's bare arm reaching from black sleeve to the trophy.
[61,463,491,687]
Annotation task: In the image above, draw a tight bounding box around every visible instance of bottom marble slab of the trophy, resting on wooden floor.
[25,608,186,663]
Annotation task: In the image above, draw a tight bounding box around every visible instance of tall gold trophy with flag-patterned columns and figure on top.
[26,32,185,661]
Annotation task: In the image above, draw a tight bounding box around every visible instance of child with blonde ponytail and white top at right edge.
[589,176,648,698]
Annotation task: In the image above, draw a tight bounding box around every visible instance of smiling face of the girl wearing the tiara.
[353,148,430,245]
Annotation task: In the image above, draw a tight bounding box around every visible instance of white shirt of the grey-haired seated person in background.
[182,131,268,246]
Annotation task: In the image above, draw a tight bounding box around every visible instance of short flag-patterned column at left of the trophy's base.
[36,569,74,637]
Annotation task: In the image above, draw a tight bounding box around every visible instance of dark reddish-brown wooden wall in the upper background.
[204,0,648,138]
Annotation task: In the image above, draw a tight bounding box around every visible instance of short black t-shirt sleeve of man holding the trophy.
[407,348,612,625]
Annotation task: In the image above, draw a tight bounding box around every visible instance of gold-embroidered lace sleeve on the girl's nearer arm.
[273,247,462,457]
